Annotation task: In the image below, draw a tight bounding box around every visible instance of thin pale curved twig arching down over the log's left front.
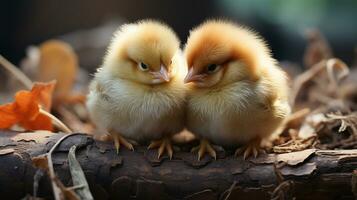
[47,133,85,200]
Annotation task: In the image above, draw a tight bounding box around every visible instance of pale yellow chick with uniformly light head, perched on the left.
[87,20,186,158]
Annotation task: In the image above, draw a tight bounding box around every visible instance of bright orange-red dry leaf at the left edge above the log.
[0,81,55,131]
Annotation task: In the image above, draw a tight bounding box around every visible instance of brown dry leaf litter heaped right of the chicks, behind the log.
[270,30,357,153]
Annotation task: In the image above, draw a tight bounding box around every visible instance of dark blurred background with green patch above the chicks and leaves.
[0,0,357,71]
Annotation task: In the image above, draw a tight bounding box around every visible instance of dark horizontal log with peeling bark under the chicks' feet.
[0,131,357,199]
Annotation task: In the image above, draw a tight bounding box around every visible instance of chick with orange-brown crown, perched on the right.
[184,20,290,159]
